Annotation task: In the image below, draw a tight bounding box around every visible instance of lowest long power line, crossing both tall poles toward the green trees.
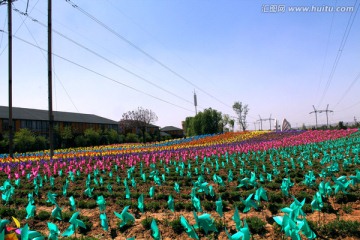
[0,30,193,112]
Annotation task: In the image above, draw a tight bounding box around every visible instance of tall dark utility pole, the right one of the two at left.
[48,0,54,159]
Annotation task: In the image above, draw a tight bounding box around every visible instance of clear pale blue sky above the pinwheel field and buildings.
[0,0,360,129]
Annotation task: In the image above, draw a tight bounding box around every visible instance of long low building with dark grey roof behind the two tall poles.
[0,106,119,136]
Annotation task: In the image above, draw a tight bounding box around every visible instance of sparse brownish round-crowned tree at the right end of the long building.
[121,107,158,142]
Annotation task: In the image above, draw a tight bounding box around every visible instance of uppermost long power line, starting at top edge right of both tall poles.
[65,0,231,108]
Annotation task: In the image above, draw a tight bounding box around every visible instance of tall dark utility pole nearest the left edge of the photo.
[8,0,14,158]
